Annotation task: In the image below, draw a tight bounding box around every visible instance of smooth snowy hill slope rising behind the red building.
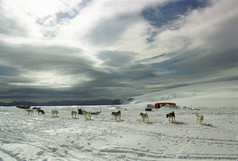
[127,81,238,107]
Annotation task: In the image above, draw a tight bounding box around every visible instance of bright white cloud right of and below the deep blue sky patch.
[139,1,238,61]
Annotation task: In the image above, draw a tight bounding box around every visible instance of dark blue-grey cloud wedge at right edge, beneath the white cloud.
[171,48,238,76]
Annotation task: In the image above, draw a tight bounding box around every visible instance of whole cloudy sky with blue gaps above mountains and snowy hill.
[0,0,238,102]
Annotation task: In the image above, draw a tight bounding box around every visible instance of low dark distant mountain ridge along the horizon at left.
[0,99,120,106]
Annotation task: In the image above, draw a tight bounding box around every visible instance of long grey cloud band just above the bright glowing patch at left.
[0,41,91,74]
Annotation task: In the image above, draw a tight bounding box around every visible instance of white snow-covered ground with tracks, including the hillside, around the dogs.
[0,81,238,161]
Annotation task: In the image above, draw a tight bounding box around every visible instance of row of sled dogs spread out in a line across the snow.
[26,108,204,125]
